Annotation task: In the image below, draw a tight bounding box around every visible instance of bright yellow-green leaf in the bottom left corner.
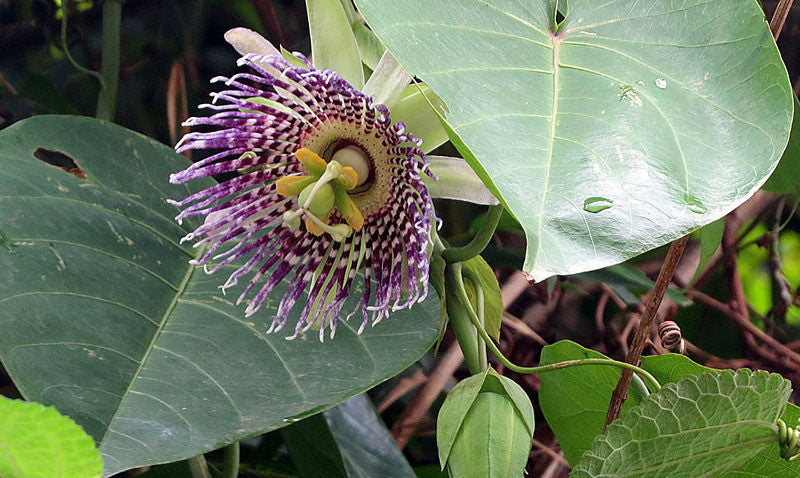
[0,396,103,478]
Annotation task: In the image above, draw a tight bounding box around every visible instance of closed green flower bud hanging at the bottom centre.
[436,368,534,478]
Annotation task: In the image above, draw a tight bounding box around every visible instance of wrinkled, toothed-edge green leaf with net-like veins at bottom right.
[570,369,792,478]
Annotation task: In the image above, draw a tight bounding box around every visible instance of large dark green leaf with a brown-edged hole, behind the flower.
[0,116,439,474]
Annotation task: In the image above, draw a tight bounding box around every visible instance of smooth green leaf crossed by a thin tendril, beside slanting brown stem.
[539,340,647,466]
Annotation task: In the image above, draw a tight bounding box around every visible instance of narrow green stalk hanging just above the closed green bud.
[444,263,485,375]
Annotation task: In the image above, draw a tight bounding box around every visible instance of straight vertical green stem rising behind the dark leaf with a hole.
[95,0,122,121]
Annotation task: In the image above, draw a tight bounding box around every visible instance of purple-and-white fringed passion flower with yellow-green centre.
[165,42,436,340]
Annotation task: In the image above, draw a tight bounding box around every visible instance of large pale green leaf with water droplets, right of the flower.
[356,0,792,281]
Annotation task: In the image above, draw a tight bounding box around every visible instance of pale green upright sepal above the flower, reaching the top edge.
[306,0,364,90]
